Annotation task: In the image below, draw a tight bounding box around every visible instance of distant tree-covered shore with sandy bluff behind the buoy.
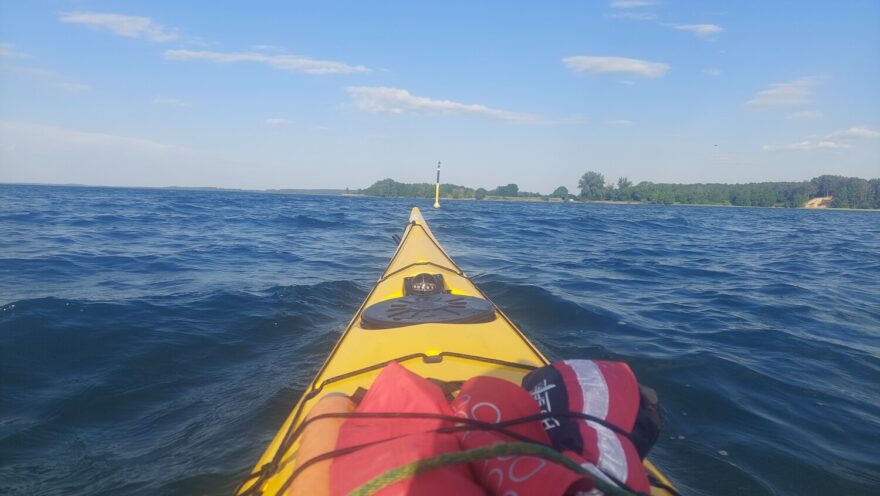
[356,171,880,209]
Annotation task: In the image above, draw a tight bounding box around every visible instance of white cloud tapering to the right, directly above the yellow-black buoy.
[347,86,542,123]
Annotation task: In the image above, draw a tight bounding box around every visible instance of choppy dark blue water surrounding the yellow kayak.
[0,185,880,495]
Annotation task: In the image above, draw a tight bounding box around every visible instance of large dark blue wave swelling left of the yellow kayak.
[0,281,366,494]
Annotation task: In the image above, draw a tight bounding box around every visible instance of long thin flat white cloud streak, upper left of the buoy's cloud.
[165,50,370,75]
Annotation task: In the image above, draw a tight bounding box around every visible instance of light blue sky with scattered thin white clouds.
[0,0,880,193]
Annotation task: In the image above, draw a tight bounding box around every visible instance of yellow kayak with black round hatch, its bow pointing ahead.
[237,208,672,495]
